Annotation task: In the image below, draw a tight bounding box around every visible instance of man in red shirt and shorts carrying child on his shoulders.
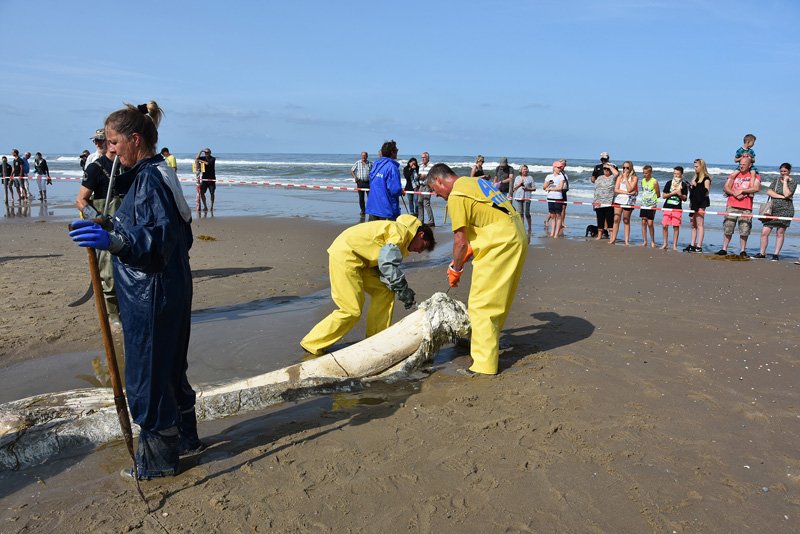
[717,155,761,258]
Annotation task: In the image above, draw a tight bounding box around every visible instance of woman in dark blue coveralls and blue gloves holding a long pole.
[70,101,204,479]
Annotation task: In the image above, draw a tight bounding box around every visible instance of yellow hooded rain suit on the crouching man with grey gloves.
[300,215,422,354]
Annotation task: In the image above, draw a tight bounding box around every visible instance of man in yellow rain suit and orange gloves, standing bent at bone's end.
[428,163,528,375]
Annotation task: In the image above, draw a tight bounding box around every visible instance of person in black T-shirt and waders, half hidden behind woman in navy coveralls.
[75,139,122,332]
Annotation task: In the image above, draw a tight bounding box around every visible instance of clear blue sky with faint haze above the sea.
[0,0,800,165]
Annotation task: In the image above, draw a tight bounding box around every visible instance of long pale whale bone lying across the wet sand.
[0,293,470,472]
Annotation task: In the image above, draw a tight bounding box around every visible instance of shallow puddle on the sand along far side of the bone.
[0,290,330,403]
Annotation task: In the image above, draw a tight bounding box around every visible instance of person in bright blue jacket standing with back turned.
[366,141,405,221]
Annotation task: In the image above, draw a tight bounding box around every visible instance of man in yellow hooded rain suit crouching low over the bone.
[300,215,436,355]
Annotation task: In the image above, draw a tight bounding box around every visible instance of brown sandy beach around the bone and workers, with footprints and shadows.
[0,210,800,533]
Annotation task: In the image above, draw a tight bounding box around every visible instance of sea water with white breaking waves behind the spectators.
[5,153,800,256]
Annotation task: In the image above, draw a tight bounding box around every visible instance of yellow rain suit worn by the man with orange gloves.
[448,178,528,374]
